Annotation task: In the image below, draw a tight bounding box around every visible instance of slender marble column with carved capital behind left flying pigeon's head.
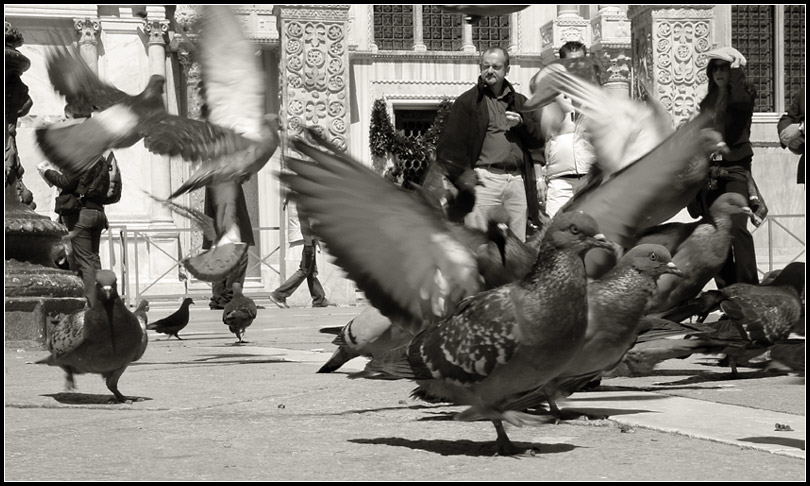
[143,18,172,224]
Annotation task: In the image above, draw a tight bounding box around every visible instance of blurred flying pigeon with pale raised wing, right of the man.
[525,58,727,278]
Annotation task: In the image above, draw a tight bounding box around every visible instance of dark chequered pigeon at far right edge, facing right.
[612,262,805,376]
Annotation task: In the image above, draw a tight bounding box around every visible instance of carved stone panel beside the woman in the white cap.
[627,5,714,126]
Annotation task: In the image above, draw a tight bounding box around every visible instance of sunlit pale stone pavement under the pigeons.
[4,301,806,481]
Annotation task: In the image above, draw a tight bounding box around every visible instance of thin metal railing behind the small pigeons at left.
[105,225,286,305]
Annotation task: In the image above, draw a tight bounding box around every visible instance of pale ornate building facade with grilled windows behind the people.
[5,4,805,304]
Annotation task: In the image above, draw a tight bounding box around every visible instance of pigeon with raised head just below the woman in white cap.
[638,193,752,313]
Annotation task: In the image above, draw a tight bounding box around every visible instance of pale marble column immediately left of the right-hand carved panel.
[590,5,631,98]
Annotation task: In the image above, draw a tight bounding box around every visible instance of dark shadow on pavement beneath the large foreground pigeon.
[349,437,577,459]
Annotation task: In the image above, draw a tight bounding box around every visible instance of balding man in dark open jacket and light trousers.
[436,47,542,240]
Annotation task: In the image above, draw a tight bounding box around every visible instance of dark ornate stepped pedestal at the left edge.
[4,22,84,344]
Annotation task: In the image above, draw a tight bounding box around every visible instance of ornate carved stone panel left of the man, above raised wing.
[276,5,349,151]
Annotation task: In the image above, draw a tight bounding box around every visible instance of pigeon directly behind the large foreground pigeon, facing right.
[502,244,681,417]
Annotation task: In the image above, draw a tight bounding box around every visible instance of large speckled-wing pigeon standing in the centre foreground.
[366,211,612,455]
